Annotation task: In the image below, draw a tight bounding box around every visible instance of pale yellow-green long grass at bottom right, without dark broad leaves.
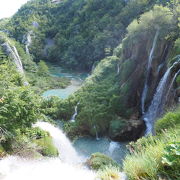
[123,127,180,180]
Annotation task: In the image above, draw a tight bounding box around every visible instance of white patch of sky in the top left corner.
[0,0,28,19]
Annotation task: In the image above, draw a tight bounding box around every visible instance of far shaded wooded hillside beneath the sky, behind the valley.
[2,0,167,70]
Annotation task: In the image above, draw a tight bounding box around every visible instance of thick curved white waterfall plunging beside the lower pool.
[35,122,81,163]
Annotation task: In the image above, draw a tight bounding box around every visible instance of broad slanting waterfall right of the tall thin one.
[143,66,173,135]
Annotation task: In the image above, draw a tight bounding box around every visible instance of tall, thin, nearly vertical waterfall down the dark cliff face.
[141,30,159,114]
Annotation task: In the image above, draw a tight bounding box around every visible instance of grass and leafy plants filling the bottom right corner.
[123,108,180,180]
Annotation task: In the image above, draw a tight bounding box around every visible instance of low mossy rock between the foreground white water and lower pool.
[86,152,119,170]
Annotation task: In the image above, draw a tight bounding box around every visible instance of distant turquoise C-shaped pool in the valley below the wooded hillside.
[42,65,88,99]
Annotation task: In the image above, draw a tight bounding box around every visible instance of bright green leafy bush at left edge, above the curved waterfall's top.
[0,87,40,131]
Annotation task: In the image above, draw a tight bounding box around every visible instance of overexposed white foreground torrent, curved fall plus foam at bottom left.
[0,122,95,180]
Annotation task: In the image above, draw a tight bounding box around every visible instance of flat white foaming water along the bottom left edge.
[0,156,95,180]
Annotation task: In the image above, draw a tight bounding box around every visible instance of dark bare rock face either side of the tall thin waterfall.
[119,32,172,118]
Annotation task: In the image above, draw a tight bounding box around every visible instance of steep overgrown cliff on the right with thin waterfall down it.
[65,3,180,140]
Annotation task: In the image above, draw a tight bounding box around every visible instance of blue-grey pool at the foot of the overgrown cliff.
[73,137,127,163]
